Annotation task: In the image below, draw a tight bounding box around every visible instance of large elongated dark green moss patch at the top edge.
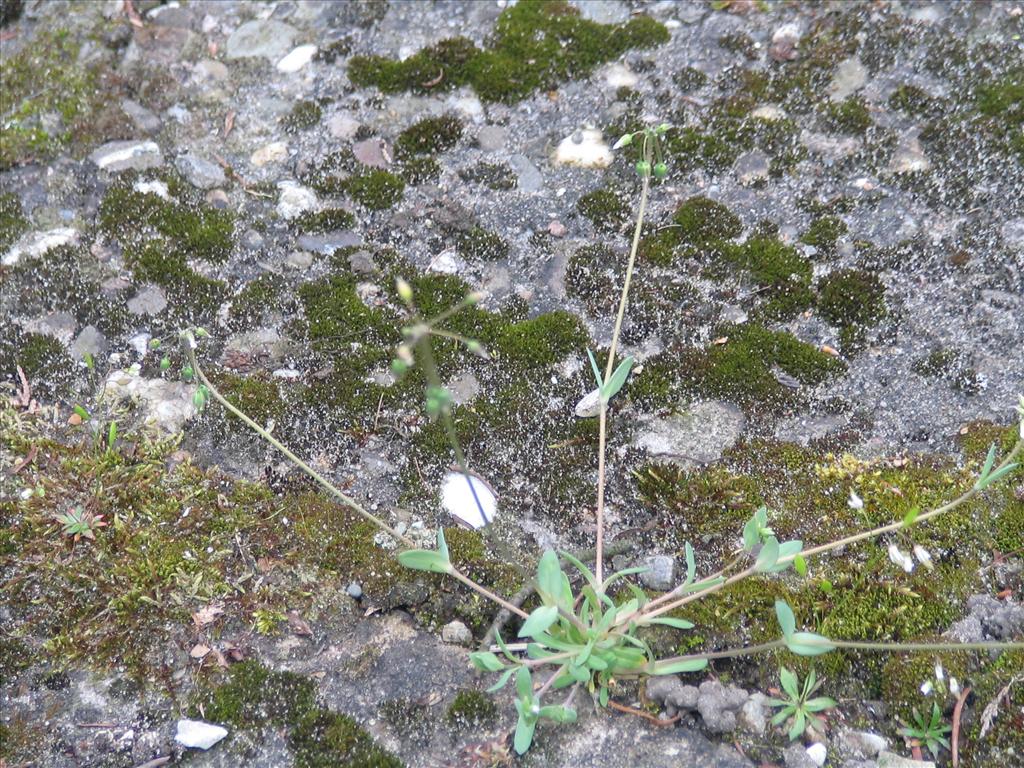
[348,0,669,103]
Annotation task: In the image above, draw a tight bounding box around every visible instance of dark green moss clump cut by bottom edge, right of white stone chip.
[288,710,402,768]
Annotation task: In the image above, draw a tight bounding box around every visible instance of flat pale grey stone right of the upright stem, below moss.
[633,400,746,467]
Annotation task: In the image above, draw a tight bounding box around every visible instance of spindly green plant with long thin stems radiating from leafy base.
[180,124,1024,754]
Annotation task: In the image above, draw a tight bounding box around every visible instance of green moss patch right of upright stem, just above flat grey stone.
[680,324,846,412]
